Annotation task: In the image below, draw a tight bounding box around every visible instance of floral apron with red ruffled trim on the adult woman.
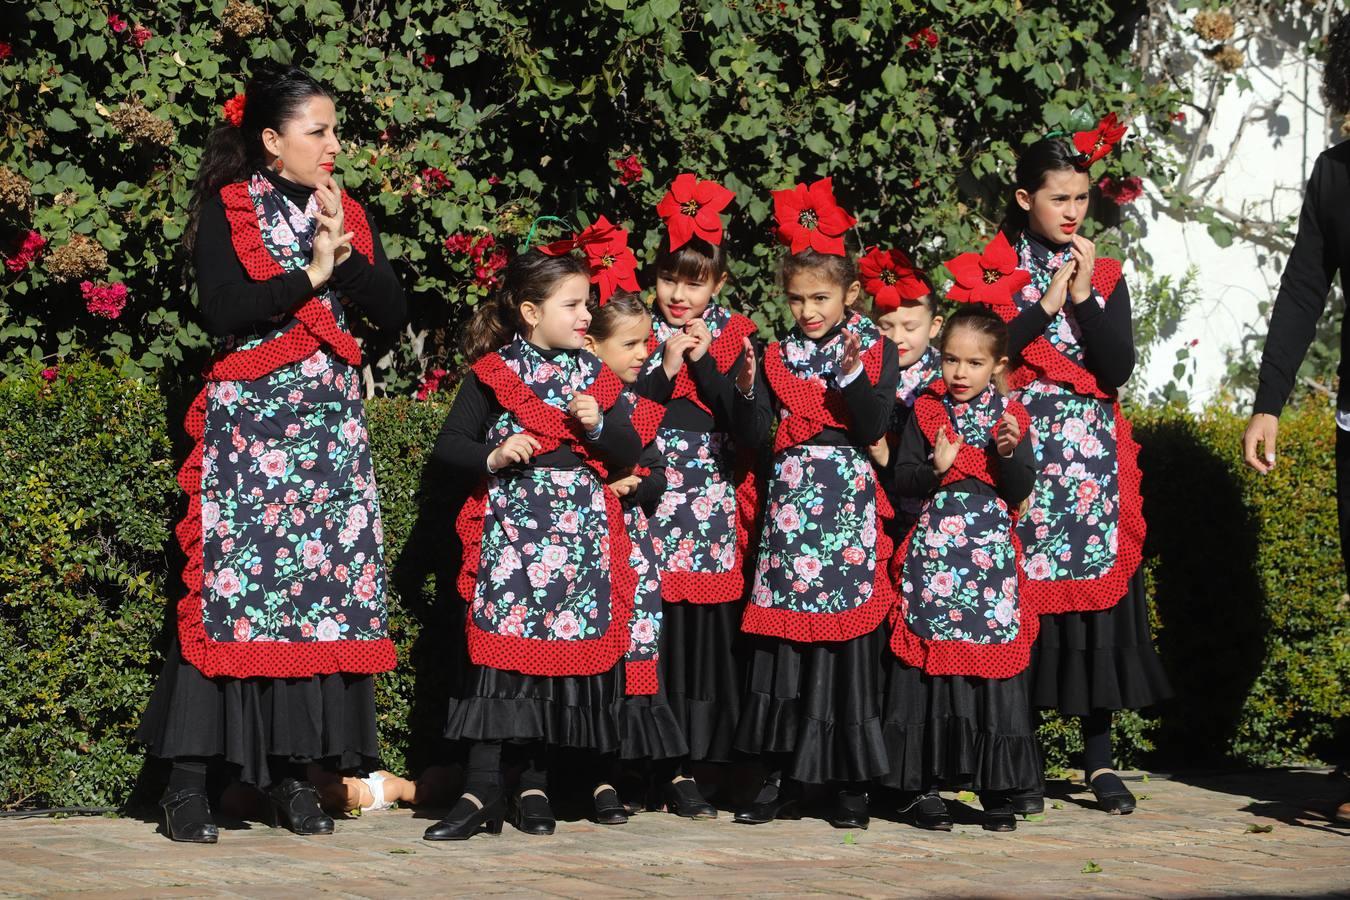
[177,175,396,677]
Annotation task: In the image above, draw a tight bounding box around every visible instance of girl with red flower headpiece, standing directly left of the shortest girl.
[736,178,899,828]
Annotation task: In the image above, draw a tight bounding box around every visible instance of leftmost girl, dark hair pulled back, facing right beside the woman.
[424,223,655,841]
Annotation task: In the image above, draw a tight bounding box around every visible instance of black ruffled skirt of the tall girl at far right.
[1029,568,1172,715]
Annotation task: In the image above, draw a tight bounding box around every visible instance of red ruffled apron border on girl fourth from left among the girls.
[741,479,895,644]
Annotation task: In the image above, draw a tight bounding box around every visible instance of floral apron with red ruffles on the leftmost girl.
[456,336,655,692]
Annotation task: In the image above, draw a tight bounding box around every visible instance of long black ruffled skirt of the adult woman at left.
[136,638,379,788]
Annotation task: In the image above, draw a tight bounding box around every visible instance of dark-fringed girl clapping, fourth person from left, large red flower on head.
[637,173,756,818]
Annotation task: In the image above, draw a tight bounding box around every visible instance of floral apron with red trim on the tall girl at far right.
[1000,236,1145,613]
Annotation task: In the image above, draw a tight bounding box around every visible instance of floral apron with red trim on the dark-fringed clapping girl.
[647,305,759,603]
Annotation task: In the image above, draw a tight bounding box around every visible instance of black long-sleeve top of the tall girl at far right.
[1008,232,1135,387]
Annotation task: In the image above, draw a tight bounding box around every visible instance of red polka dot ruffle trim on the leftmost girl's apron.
[455,354,644,694]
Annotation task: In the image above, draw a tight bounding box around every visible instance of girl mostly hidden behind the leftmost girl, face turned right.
[586,290,689,824]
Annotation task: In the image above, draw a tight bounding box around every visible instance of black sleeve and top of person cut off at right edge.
[1253,142,1350,416]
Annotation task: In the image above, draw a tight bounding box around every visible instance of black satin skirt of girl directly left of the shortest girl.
[736,626,890,784]
